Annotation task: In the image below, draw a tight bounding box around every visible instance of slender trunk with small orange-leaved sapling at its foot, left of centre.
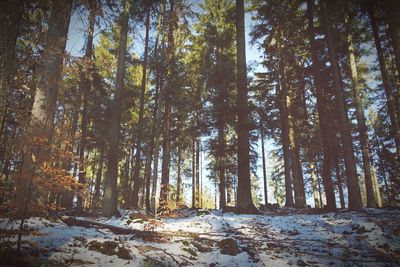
[159,0,178,207]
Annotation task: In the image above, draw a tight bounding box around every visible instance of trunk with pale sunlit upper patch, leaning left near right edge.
[346,18,376,208]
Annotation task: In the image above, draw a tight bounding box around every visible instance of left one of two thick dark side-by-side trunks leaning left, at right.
[307,0,336,210]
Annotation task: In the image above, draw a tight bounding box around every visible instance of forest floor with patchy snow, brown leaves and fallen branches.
[0,209,400,267]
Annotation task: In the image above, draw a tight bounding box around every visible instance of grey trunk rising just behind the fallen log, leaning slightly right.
[103,0,131,217]
